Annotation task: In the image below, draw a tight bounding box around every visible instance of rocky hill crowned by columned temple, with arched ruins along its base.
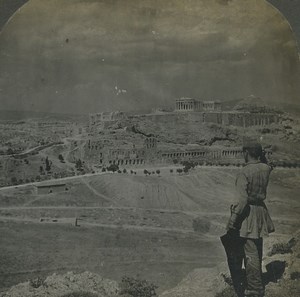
[73,98,298,166]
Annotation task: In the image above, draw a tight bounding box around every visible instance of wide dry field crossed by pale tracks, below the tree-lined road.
[0,167,300,292]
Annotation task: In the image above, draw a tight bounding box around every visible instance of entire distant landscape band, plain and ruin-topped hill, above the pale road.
[0,97,300,186]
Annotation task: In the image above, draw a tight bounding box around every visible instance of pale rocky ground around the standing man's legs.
[161,232,300,297]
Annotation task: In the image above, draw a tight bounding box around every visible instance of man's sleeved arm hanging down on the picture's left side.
[227,173,248,230]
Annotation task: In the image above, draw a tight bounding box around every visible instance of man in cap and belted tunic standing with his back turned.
[222,143,274,297]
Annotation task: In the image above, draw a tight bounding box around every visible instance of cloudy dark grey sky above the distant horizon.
[0,0,300,113]
